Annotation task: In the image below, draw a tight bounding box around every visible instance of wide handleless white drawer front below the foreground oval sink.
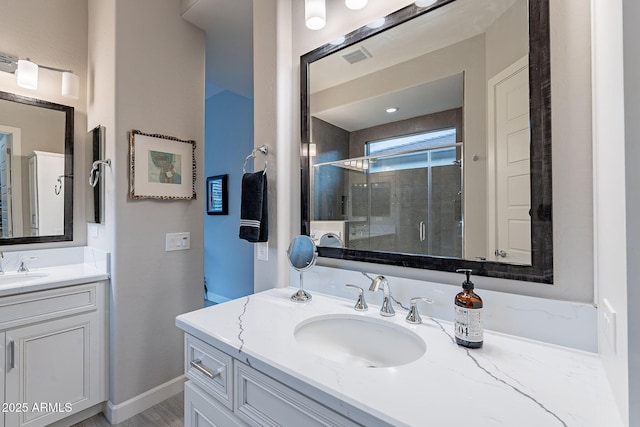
[234,360,360,427]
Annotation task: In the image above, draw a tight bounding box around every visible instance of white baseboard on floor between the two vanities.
[104,375,186,424]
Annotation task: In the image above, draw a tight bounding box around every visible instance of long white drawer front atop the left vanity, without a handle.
[0,283,98,330]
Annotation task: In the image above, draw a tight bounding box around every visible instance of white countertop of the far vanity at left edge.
[0,263,109,297]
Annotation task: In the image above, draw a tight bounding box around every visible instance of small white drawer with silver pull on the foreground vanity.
[184,334,233,409]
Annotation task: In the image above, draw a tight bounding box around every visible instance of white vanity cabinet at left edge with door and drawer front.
[0,282,107,427]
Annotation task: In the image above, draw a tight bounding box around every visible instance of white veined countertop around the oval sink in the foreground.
[176,288,623,427]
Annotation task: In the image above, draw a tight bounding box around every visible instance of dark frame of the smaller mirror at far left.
[0,91,74,247]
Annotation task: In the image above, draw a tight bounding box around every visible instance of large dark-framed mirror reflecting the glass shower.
[300,0,553,283]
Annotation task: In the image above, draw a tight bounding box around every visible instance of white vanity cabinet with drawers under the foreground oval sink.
[184,334,360,427]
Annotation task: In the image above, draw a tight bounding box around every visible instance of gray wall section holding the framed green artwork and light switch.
[88,0,204,405]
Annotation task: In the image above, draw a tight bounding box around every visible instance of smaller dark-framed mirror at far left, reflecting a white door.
[0,92,74,246]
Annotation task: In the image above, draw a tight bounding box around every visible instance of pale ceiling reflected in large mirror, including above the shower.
[310,0,520,131]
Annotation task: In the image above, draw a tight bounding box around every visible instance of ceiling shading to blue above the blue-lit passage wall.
[182,0,253,98]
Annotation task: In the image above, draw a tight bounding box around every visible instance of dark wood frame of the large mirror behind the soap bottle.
[300,0,553,283]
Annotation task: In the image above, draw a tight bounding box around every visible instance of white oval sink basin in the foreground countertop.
[294,314,427,368]
